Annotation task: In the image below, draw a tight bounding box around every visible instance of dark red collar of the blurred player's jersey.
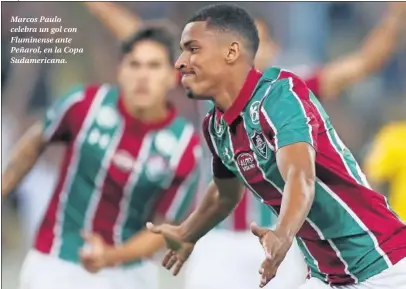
[118,96,177,132]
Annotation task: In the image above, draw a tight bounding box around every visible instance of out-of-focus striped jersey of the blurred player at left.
[35,84,201,262]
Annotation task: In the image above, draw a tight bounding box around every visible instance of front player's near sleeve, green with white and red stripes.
[260,74,319,151]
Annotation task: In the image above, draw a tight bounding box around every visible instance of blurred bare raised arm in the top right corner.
[315,2,406,98]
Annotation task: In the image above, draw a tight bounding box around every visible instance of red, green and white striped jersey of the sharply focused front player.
[203,68,406,285]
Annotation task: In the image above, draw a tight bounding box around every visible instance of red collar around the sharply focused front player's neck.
[220,68,262,125]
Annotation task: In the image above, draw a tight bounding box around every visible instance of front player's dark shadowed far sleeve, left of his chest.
[203,111,235,179]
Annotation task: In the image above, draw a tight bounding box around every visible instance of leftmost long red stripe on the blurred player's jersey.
[35,85,99,253]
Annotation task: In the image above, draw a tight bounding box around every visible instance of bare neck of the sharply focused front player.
[213,66,252,111]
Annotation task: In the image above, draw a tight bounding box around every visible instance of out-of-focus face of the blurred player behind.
[118,40,176,109]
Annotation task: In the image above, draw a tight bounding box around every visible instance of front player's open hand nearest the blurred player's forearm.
[147,223,195,276]
